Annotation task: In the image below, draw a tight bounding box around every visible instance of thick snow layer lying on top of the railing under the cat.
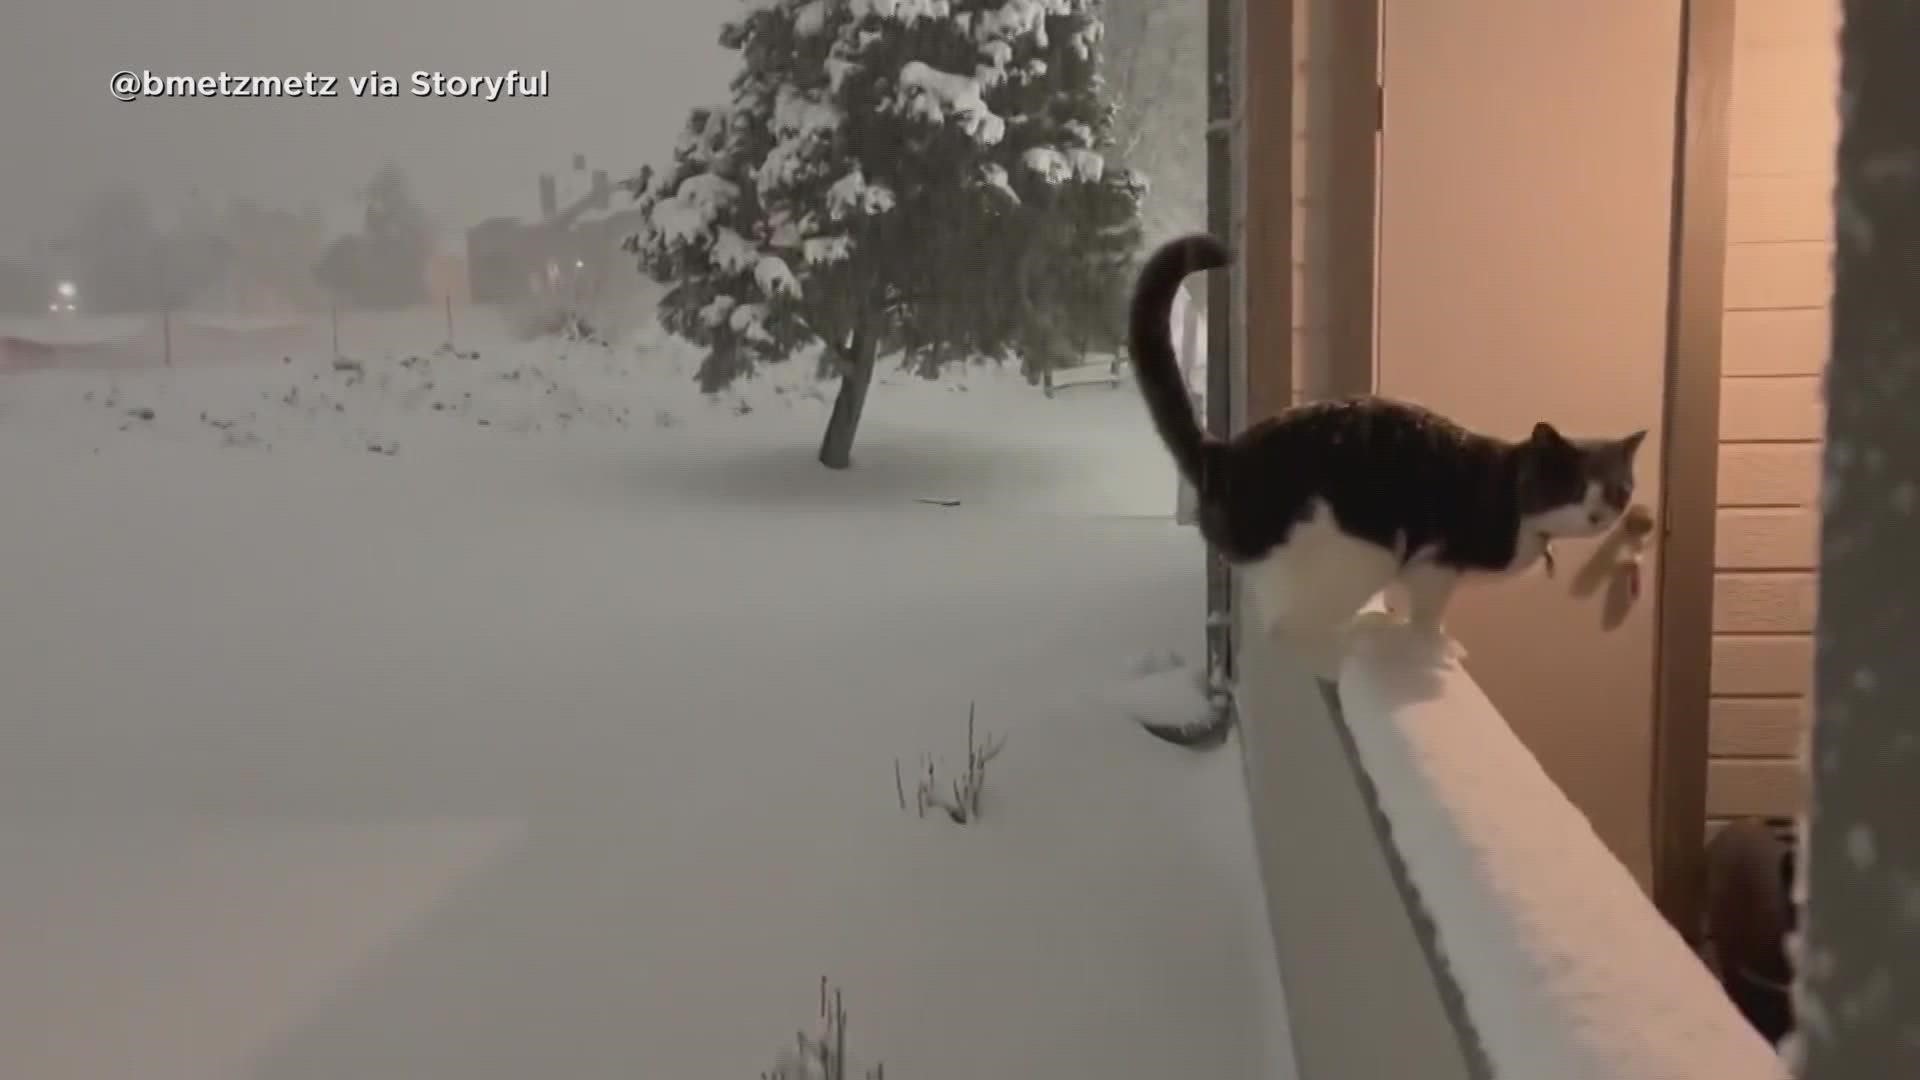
[1313,626,1788,1080]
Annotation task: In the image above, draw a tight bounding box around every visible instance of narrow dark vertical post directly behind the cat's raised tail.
[1206,0,1260,687]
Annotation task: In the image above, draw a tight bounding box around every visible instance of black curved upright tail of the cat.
[1127,233,1227,496]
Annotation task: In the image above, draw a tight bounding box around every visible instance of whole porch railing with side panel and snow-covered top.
[1236,588,1788,1080]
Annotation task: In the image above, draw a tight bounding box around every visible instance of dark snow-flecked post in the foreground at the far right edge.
[1793,0,1920,1080]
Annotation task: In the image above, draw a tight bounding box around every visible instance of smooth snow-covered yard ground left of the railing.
[0,309,1290,1080]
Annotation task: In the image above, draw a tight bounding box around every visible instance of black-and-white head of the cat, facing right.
[1515,421,1647,536]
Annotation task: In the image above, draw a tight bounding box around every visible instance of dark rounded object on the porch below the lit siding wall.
[1707,819,1799,1043]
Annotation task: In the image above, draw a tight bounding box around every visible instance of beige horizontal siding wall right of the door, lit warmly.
[1707,0,1839,819]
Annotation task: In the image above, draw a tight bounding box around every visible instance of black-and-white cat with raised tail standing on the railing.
[1127,234,1647,678]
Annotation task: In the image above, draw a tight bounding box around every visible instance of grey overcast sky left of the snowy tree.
[0,0,737,254]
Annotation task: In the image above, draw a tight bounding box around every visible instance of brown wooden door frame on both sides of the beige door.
[1290,0,1738,942]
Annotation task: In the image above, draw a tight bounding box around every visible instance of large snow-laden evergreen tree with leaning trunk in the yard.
[630,0,1142,469]
